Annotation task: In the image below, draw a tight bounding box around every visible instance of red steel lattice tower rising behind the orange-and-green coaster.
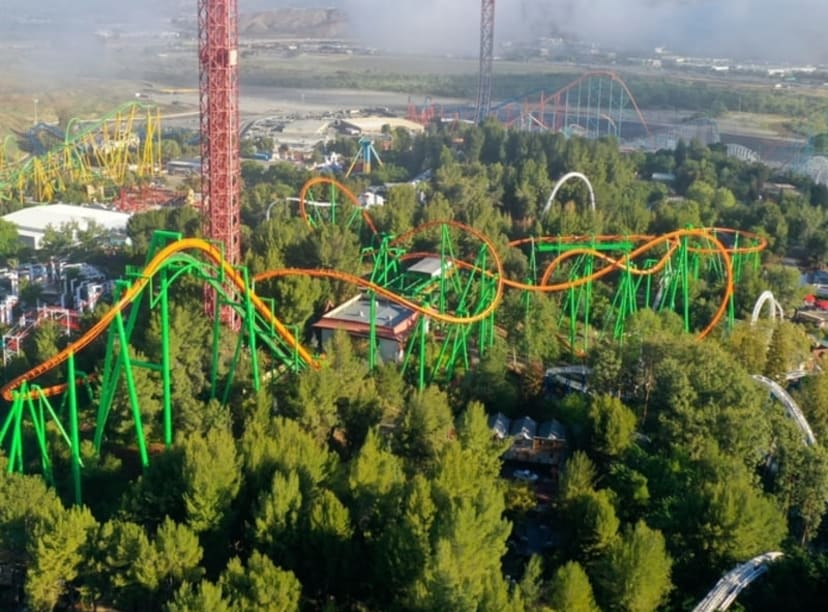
[198,0,241,322]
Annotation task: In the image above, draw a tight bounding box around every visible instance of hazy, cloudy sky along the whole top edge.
[0,0,828,63]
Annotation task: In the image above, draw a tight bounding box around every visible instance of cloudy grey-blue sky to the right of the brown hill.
[326,0,828,63]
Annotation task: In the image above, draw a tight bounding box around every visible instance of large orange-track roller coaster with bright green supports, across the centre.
[0,178,765,501]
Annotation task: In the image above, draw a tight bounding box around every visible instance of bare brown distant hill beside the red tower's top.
[239,8,349,38]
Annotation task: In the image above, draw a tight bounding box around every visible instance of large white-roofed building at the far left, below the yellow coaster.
[3,204,132,250]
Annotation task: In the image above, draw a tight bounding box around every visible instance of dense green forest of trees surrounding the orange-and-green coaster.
[0,121,828,612]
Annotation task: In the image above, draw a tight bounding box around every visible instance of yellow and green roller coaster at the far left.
[0,102,161,202]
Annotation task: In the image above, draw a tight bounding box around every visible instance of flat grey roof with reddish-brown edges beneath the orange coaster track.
[313,294,419,340]
